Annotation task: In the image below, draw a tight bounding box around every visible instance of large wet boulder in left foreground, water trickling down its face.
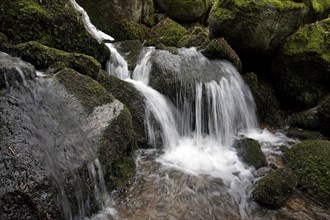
[0,55,136,219]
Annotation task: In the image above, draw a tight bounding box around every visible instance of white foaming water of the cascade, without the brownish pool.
[72,0,294,218]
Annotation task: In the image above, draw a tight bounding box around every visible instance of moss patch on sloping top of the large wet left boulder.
[55,68,114,113]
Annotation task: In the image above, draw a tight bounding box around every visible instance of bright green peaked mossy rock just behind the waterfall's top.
[147,18,187,48]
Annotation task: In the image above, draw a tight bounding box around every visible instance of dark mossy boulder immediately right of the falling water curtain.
[243,72,283,126]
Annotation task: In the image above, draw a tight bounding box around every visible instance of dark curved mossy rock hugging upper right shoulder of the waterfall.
[202,38,242,72]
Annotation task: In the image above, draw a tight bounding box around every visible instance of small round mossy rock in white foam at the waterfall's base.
[233,138,267,169]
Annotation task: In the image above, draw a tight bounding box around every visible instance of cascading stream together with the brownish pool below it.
[68,0,296,219]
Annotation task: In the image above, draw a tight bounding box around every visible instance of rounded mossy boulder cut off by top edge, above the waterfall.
[155,0,212,21]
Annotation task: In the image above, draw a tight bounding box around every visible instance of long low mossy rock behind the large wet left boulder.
[3,41,102,77]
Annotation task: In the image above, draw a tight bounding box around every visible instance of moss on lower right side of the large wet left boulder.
[98,107,136,191]
